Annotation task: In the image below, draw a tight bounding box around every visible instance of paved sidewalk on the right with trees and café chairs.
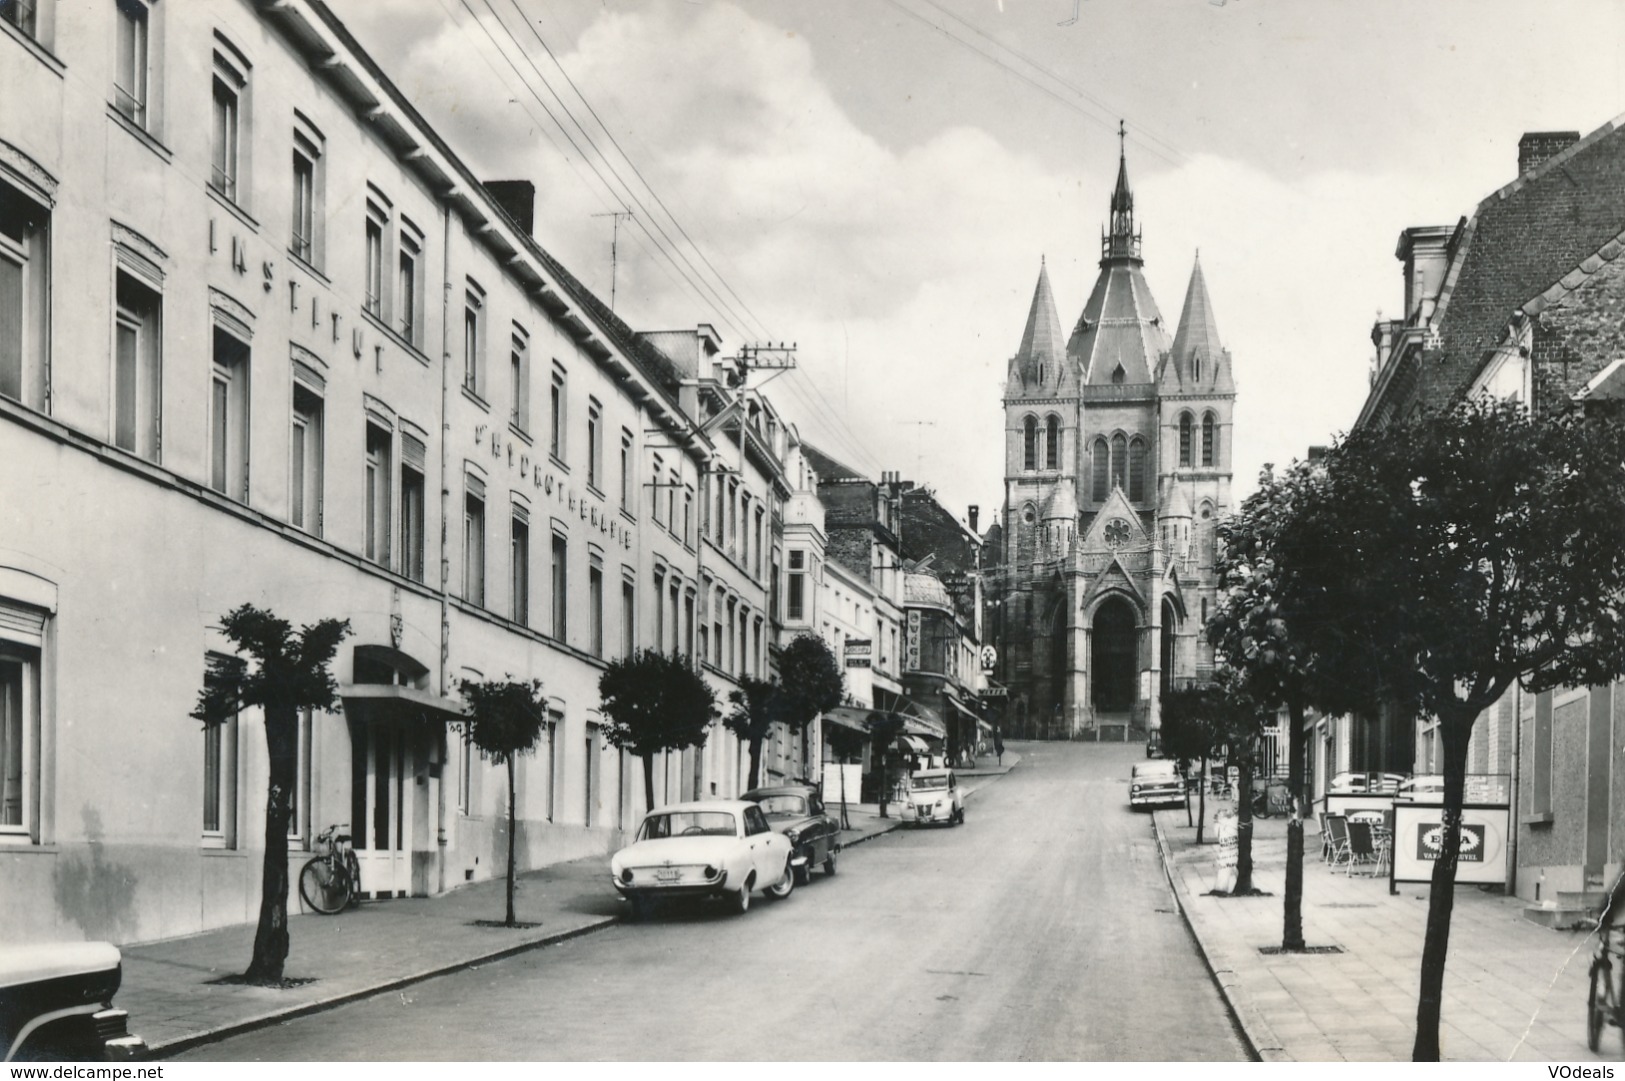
[1155,805,1599,1061]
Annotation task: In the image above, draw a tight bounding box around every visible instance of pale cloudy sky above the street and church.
[330,0,1625,528]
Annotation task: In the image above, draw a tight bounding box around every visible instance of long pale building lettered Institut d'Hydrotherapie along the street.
[0,0,783,941]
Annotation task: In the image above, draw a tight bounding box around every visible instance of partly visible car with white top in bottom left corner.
[0,943,146,1061]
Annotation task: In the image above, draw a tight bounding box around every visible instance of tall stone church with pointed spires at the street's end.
[990,141,1235,738]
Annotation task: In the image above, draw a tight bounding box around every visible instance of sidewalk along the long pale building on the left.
[126,754,1017,1058]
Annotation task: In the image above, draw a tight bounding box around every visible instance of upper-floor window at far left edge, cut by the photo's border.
[0,179,50,410]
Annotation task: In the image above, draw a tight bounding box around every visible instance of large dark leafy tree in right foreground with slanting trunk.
[1271,400,1625,1061]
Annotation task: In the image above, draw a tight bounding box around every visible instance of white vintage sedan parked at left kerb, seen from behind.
[609,800,796,920]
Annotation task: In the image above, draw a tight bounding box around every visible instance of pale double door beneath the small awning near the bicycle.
[349,720,413,897]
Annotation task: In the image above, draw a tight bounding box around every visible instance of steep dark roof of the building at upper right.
[1417,117,1625,405]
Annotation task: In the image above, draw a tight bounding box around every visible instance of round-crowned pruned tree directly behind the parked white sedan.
[598,649,717,810]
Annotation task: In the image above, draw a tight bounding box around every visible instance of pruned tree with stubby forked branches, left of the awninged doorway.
[192,605,349,987]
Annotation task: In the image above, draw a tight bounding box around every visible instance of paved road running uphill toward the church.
[180,743,1245,1061]
